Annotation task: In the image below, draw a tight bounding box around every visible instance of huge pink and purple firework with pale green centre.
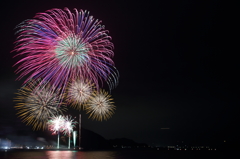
[13,8,119,90]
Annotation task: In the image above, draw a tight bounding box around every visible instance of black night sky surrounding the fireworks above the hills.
[0,0,239,145]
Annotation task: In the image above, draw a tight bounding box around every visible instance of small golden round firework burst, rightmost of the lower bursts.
[86,90,116,121]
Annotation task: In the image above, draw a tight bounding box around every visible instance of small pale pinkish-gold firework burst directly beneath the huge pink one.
[66,80,94,110]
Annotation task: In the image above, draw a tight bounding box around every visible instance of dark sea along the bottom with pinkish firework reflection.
[0,150,229,159]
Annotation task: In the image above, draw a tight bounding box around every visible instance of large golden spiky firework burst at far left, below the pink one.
[14,81,66,130]
